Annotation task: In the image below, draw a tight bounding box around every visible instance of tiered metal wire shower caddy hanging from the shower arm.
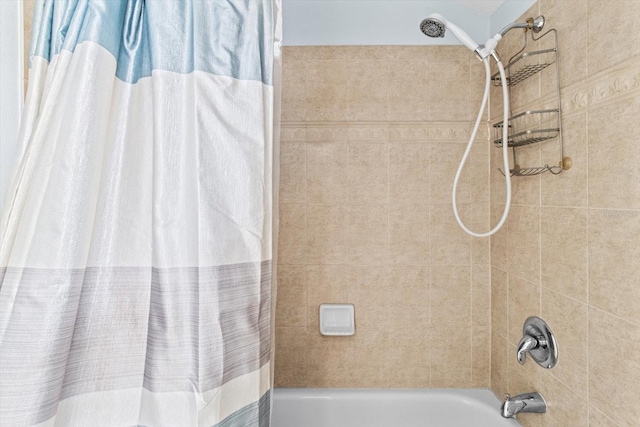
[491,29,571,176]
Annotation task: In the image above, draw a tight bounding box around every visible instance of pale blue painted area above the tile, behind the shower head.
[280,0,536,46]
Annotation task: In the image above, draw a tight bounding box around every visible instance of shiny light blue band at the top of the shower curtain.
[29,0,274,85]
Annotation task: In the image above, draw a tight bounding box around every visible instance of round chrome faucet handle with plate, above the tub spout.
[517,316,558,369]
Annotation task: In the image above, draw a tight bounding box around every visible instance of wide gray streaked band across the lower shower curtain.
[0,261,271,425]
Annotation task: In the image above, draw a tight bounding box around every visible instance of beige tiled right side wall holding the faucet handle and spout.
[491,0,640,427]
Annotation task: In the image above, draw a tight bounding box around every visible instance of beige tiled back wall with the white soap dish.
[276,46,491,387]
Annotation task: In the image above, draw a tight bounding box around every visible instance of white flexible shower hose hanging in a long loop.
[452,57,511,237]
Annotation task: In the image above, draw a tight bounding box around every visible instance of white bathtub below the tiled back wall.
[271,388,520,427]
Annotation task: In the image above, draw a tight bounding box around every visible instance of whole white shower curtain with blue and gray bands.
[0,0,281,427]
